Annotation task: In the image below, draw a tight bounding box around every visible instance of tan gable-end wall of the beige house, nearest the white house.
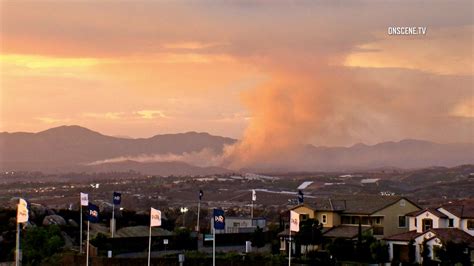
[372,199,420,237]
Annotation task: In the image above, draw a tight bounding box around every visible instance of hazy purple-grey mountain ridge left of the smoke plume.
[0,126,235,164]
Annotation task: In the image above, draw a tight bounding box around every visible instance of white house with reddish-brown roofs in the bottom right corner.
[385,200,474,263]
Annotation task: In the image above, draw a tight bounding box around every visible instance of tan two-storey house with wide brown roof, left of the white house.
[280,195,420,254]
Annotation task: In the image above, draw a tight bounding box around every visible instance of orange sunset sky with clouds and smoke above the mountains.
[0,0,474,146]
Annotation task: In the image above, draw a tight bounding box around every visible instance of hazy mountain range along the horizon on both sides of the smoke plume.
[0,126,474,176]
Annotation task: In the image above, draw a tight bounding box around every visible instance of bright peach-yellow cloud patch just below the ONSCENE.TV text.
[344,25,474,75]
